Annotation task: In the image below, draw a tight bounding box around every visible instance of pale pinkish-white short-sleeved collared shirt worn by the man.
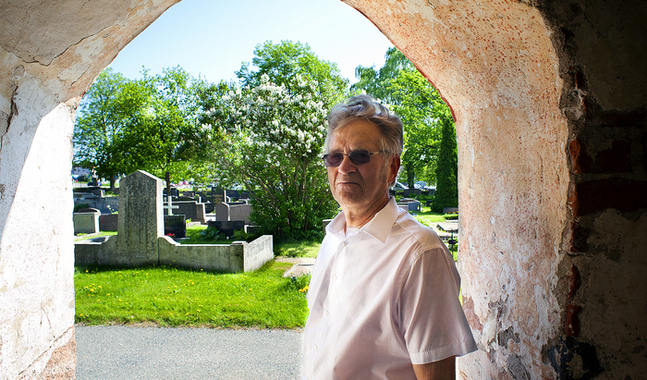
[302,199,477,380]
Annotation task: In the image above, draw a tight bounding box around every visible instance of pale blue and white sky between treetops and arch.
[110,0,393,84]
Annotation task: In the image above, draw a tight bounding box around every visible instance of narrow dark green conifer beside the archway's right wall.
[431,123,458,212]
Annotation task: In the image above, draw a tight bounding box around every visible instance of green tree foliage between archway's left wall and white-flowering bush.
[74,67,211,189]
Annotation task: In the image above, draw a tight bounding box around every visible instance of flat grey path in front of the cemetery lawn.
[76,326,302,380]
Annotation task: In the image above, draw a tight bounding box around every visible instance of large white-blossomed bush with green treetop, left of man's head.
[203,42,345,240]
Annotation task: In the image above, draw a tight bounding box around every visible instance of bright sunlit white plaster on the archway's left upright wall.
[0,78,74,379]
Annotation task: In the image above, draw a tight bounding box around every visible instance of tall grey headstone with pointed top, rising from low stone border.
[117,170,164,266]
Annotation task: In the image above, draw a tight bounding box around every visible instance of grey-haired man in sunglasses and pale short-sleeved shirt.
[302,95,476,380]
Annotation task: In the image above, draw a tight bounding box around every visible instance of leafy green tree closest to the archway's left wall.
[73,68,147,190]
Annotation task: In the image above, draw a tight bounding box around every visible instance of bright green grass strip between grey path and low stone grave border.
[74,262,310,329]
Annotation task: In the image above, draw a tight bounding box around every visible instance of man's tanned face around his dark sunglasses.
[328,120,400,214]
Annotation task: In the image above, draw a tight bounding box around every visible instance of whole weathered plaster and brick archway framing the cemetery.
[0,0,647,379]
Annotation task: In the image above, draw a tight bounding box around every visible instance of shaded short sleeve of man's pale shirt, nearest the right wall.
[400,248,477,364]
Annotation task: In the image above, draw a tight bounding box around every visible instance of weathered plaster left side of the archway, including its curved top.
[0,0,178,379]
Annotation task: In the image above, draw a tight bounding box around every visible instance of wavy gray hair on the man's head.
[324,95,404,156]
